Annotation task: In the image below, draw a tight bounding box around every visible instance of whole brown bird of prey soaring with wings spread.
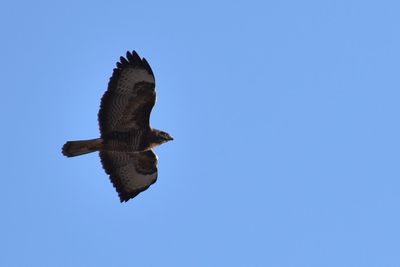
[62,51,173,202]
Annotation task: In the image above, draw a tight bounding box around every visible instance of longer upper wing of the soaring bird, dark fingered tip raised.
[98,51,156,136]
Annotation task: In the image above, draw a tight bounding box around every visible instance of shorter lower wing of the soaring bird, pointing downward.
[100,150,157,202]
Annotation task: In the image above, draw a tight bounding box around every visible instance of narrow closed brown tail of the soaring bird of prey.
[62,138,103,157]
